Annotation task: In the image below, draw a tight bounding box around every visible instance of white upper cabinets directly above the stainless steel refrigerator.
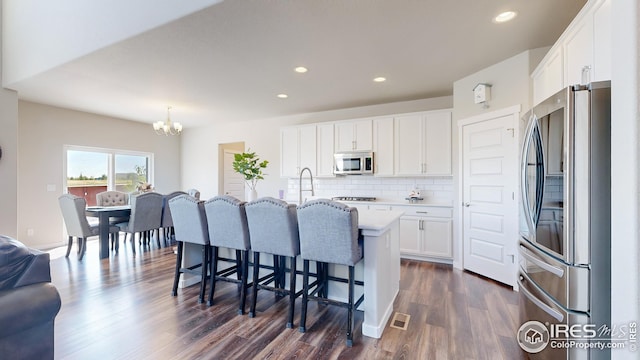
[531,0,612,105]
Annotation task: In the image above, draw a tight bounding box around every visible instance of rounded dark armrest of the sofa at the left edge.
[0,283,62,339]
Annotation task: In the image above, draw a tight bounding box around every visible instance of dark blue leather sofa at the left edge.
[0,235,61,359]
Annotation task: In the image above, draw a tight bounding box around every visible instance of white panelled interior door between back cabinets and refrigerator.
[462,112,519,286]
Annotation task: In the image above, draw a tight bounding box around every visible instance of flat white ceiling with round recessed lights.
[9,0,586,127]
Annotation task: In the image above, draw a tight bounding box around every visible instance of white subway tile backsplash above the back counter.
[286,176,454,203]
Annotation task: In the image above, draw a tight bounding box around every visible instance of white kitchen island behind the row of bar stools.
[179,210,403,338]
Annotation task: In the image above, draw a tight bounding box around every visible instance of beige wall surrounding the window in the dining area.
[17,101,182,248]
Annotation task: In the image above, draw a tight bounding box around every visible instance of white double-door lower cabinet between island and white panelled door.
[393,206,453,261]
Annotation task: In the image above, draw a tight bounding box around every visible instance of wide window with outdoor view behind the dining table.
[64,146,153,206]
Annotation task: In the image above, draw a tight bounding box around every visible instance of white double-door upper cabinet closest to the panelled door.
[394,111,451,176]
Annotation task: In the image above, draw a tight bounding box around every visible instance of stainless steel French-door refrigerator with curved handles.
[519,82,611,359]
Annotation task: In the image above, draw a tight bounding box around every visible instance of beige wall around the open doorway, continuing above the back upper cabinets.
[182,96,452,199]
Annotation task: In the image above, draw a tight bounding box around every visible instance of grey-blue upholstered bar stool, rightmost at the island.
[298,199,364,347]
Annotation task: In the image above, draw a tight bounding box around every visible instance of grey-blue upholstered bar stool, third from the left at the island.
[245,197,300,328]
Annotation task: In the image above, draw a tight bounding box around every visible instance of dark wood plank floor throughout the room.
[51,241,526,360]
